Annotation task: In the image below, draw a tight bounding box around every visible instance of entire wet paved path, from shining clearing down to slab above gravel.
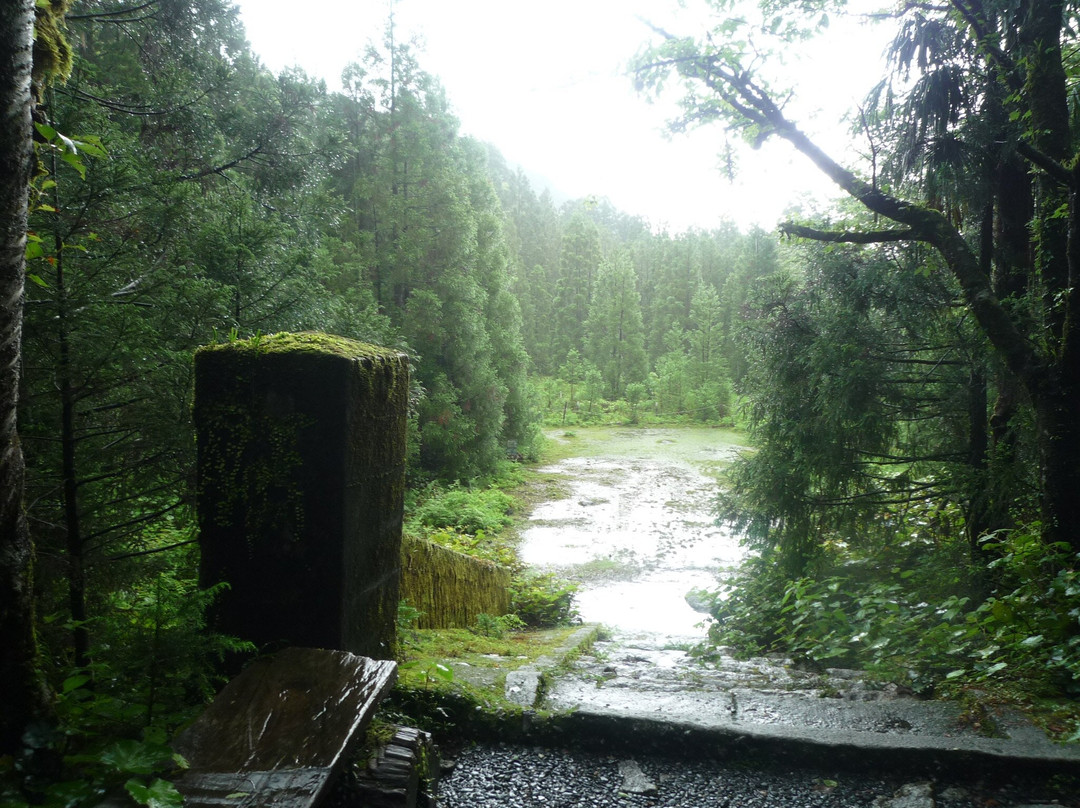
[521,430,1080,776]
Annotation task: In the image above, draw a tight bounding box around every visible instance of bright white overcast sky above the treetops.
[237,0,886,232]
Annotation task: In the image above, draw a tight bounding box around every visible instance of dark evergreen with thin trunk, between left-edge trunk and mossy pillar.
[22,0,341,666]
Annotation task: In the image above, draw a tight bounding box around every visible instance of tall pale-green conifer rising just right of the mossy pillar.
[338,28,532,479]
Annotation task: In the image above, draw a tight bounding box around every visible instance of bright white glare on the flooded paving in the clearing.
[519,430,743,637]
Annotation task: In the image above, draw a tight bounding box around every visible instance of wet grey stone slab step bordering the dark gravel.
[542,635,1080,775]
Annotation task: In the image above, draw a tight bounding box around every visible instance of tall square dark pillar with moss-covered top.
[193,334,409,659]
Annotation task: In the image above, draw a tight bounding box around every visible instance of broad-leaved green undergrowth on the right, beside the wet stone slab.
[698,514,1080,741]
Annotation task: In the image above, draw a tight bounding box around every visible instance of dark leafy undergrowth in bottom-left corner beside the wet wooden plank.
[0,535,253,808]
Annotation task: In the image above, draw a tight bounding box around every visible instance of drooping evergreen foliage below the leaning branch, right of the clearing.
[728,239,989,571]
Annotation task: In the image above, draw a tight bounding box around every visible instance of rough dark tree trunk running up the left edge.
[0,0,45,755]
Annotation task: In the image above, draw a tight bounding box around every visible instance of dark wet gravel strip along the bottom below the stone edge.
[438,744,1077,808]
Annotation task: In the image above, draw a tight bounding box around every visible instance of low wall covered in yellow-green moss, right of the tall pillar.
[401,538,510,629]
